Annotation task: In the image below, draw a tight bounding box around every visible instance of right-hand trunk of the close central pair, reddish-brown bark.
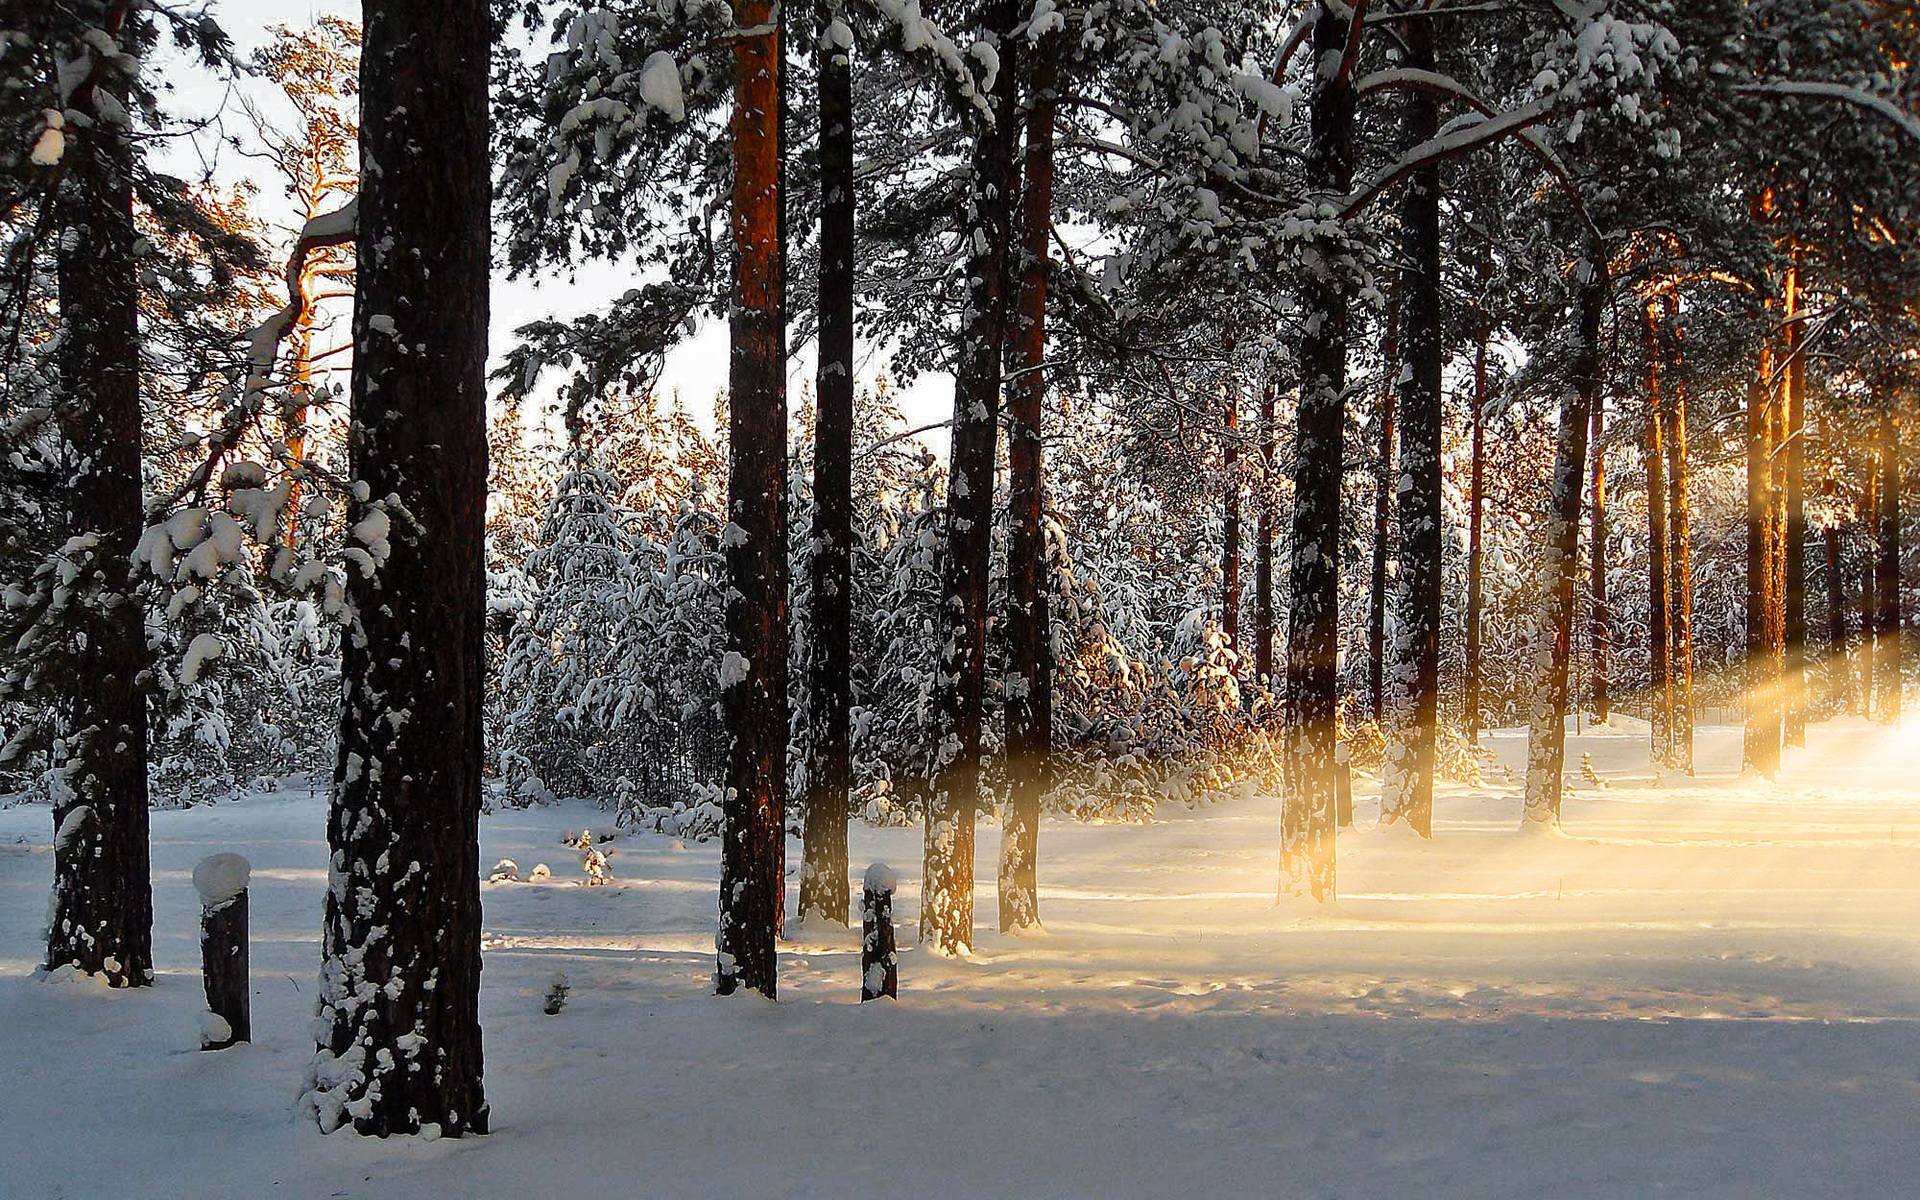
[1000,23,1060,933]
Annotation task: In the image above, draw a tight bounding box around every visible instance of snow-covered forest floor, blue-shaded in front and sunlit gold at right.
[0,720,1920,1200]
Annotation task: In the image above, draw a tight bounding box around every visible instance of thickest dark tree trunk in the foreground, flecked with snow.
[305,0,492,1137]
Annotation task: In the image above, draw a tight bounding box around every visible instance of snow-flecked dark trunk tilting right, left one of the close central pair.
[920,0,1018,954]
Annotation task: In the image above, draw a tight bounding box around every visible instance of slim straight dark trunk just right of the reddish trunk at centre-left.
[799,0,854,925]
